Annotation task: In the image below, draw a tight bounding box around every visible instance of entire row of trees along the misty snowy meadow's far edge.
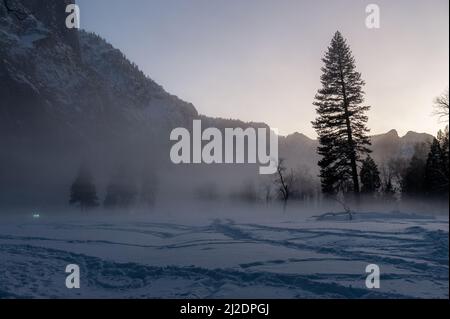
[70,31,449,210]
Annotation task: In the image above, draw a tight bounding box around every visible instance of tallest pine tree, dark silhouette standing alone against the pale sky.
[312,31,370,195]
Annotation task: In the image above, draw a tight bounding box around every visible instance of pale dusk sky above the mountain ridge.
[77,0,449,138]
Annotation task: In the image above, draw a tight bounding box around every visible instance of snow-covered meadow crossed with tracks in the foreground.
[0,208,449,298]
